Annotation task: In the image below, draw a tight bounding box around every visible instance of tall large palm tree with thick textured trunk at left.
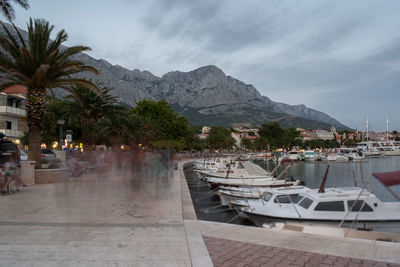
[0,19,101,163]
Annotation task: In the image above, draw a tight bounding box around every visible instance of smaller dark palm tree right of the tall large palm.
[63,85,121,157]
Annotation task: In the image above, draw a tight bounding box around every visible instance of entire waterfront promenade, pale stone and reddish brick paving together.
[0,154,400,266]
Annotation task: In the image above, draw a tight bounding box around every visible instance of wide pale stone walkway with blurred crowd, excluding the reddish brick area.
[0,156,212,267]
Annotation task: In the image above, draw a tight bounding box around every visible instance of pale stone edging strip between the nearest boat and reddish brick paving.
[199,221,400,264]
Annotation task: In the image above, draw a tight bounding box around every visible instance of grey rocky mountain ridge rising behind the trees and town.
[0,23,348,129]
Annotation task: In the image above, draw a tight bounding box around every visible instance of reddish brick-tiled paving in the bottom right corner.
[203,236,400,267]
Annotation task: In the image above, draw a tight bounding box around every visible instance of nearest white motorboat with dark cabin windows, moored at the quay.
[242,187,400,230]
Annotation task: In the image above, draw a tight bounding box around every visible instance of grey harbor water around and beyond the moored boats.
[184,156,400,232]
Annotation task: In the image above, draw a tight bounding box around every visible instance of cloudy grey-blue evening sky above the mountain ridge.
[10,0,400,131]
